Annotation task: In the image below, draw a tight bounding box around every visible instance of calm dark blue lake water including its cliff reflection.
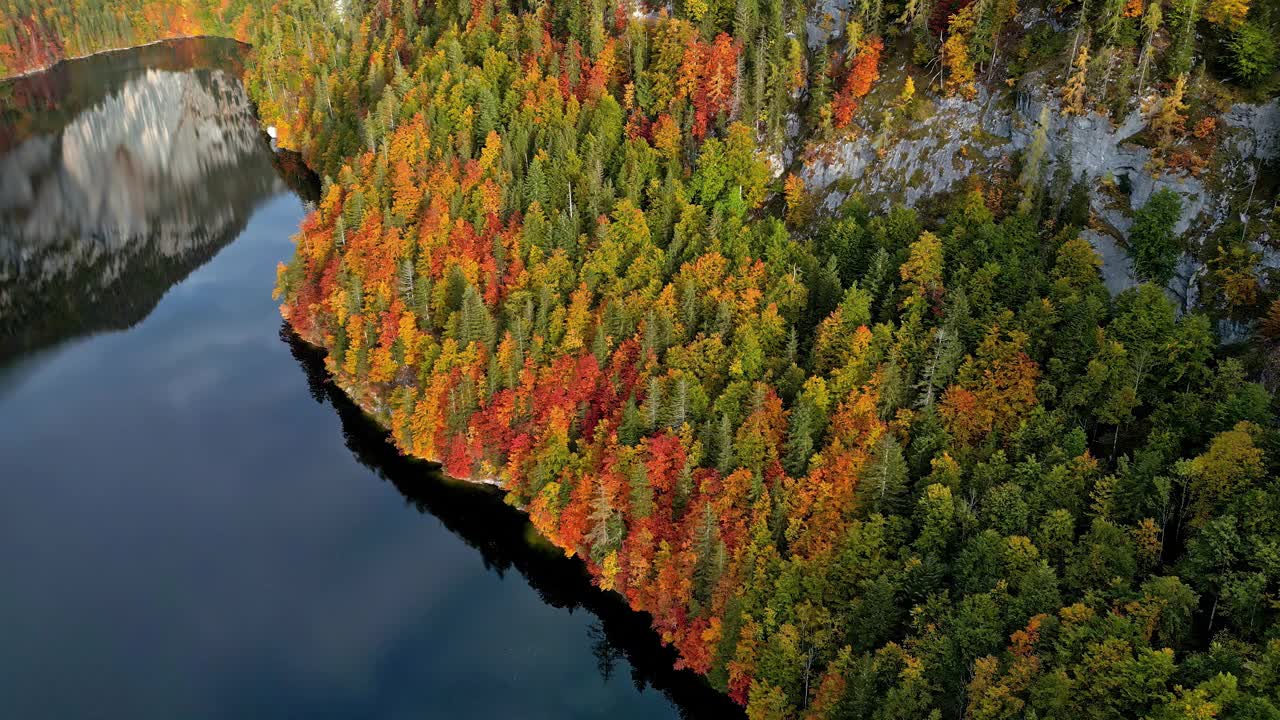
[0,41,740,720]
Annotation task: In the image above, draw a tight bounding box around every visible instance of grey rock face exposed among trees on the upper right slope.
[801,85,1280,298]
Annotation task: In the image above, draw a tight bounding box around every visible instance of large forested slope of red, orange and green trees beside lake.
[5,0,1280,720]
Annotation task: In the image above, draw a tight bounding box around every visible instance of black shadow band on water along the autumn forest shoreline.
[280,325,744,720]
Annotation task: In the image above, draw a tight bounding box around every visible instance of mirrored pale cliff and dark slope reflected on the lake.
[0,46,287,366]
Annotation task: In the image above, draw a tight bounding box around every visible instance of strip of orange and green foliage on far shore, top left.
[0,0,265,78]
